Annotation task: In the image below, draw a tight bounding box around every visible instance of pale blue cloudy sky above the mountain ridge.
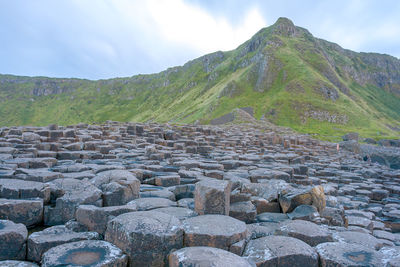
[0,0,400,79]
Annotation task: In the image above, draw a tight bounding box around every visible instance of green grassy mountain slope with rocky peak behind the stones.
[0,18,400,140]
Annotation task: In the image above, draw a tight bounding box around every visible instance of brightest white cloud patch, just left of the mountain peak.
[146,0,266,53]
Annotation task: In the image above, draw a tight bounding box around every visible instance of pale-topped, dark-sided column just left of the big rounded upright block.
[44,178,102,225]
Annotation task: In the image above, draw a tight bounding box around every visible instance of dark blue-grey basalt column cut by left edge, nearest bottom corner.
[0,220,28,260]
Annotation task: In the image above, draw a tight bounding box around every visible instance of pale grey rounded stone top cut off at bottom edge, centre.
[168,247,255,267]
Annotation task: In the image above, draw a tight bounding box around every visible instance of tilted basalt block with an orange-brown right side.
[279,185,326,213]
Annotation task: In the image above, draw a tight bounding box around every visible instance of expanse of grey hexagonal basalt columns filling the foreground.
[0,122,400,267]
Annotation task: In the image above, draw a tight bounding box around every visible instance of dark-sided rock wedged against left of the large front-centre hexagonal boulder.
[75,205,136,235]
